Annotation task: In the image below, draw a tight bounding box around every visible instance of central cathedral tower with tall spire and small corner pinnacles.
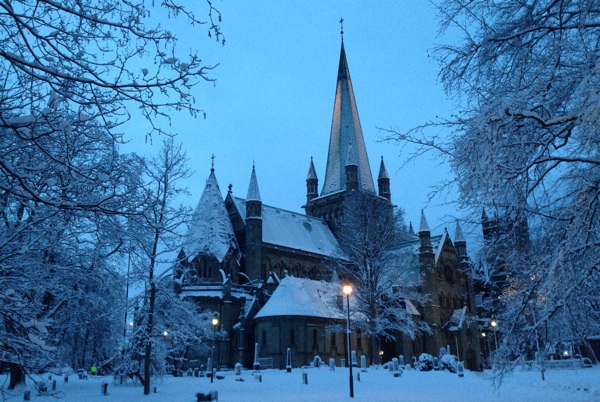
[303,39,392,233]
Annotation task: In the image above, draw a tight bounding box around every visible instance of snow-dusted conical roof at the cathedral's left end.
[183,169,239,262]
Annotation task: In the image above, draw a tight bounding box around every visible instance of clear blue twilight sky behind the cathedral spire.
[125,0,470,245]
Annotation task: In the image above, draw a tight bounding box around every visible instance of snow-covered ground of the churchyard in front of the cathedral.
[0,367,600,402]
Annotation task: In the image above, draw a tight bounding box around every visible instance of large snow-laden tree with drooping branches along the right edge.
[388,0,600,374]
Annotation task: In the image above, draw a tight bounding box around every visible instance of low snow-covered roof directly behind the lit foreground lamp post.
[256,276,345,319]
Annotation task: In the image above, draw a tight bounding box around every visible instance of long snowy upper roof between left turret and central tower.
[232,197,346,259]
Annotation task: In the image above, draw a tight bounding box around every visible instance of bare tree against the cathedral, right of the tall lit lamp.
[338,191,427,361]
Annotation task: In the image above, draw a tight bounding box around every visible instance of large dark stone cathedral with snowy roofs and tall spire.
[173,40,481,370]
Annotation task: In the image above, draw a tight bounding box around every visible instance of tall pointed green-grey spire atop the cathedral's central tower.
[321,42,375,196]
